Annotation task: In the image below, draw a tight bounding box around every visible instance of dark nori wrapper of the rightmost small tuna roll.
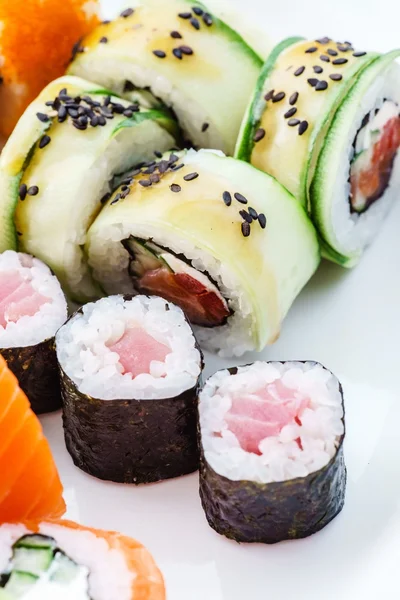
[199,368,347,544]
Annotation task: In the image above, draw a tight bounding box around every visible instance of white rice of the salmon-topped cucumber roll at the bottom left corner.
[0,523,135,600]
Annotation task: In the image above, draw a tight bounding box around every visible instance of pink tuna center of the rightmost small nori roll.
[225,380,310,454]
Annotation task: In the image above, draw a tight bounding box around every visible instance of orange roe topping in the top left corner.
[0,0,99,136]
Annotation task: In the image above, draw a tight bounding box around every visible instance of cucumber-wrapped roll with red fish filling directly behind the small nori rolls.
[86,150,319,355]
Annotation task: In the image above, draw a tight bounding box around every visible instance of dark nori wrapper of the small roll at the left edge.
[0,338,61,414]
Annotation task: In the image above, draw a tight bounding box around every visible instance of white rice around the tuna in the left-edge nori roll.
[0,250,67,348]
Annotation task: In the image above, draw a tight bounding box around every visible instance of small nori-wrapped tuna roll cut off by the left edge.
[0,250,67,414]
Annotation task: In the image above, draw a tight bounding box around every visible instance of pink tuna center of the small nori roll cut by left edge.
[0,271,52,327]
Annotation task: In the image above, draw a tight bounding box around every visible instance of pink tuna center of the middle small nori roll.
[109,327,171,377]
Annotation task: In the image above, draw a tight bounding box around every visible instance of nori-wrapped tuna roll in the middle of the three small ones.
[56,296,203,484]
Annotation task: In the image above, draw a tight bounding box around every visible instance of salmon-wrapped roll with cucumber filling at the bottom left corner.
[0,521,165,600]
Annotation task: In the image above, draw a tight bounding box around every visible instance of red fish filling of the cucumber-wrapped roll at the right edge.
[350,100,400,213]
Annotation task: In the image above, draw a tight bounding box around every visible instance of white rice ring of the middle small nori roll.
[56,296,202,400]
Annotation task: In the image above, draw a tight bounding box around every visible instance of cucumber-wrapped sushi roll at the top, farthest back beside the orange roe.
[68,0,262,154]
